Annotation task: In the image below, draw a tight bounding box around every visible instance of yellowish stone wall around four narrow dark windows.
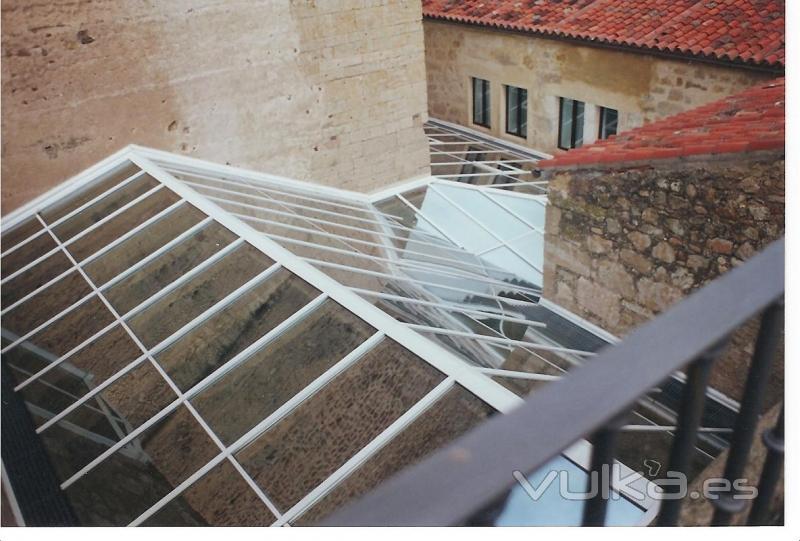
[423,19,775,153]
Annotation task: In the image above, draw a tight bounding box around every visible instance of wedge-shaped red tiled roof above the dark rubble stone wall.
[538,78,786,168]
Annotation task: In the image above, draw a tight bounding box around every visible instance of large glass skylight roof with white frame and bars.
[0,143,664,525]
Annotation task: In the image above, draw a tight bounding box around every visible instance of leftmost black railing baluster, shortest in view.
[583,417,625,526]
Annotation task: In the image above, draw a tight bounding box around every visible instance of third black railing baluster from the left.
[711,301,783,526]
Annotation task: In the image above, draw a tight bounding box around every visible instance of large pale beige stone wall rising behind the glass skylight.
[2,0,429,212]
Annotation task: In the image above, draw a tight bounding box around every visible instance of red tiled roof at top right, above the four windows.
[422,0,786,67]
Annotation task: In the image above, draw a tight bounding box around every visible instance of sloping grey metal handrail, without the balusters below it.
[320,239,784,526]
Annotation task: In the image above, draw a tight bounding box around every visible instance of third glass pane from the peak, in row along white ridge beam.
[62,188,179,262]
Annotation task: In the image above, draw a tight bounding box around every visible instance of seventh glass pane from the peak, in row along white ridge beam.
[156,269,320,391]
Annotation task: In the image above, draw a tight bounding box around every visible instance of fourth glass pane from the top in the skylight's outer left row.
[3,271,92,337]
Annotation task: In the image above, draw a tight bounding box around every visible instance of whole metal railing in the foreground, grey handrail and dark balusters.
[321,239,784,526]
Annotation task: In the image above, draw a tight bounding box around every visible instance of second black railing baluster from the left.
[658,340,727,526]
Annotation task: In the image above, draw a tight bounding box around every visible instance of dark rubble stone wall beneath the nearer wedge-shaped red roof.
[544,152,784,406]
